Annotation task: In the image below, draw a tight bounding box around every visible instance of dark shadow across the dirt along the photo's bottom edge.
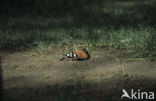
[4,76,156,101]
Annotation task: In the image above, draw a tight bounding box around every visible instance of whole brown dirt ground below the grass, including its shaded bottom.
[0,49,156,101]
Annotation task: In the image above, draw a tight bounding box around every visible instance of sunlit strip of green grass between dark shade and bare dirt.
[0,26,156,55]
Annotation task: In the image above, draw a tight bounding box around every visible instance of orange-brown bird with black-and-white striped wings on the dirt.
[60,48,90,61]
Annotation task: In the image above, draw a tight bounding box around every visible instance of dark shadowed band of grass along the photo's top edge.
[0,0,156,30]
